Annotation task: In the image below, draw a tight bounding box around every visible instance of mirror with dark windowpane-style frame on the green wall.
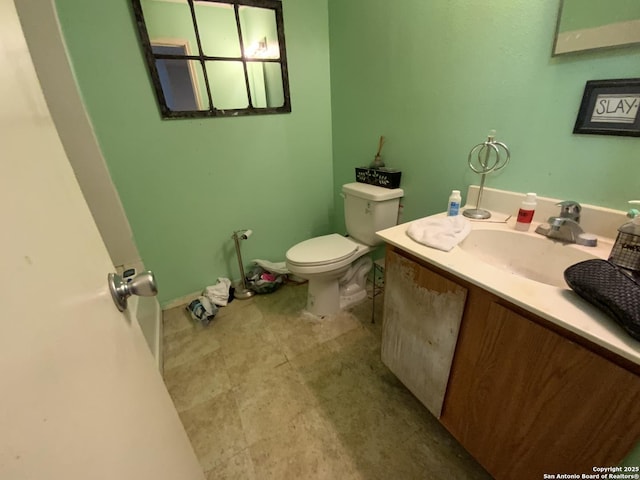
[132,0,291,118]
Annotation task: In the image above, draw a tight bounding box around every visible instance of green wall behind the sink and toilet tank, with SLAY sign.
[329,0,640,232]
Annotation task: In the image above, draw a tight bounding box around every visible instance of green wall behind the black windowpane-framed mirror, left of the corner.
[56,0,333,304]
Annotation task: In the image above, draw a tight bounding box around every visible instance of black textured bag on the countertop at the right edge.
[564,260,640,340]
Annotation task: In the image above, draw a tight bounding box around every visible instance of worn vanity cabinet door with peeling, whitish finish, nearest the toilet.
[382,250,467,417]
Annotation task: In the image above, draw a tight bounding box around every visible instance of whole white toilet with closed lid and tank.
[286,183,404,317]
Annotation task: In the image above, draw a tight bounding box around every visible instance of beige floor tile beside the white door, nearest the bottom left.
[180,392,247,472]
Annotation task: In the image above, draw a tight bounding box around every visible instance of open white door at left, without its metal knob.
[0,0,204,480]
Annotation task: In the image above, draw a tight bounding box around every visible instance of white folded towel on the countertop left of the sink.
[407,215,471,252]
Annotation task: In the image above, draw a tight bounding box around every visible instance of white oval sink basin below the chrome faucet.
[459,229,601,288]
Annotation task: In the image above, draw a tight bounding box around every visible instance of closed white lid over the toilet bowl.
[287,233,358,265]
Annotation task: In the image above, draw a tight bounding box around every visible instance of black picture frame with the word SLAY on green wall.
[573,78,640,137]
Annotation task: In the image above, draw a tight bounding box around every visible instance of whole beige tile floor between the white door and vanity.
[164,285,490,480]
